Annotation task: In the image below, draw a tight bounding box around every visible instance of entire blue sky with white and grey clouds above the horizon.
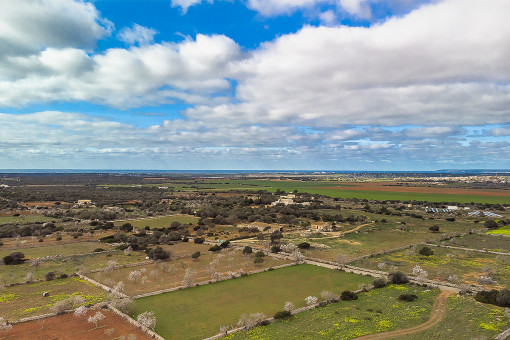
[0,0,510,170]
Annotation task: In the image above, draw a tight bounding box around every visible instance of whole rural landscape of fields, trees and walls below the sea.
[0,173,510,339]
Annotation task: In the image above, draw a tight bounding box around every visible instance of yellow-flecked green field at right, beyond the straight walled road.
[353,246,510,288]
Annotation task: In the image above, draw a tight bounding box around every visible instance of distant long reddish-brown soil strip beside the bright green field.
[322,182,510,197]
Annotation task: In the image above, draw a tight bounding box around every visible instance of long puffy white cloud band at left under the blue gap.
[0,34,240,108]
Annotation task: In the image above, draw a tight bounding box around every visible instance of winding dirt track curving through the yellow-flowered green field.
[356,291,455,340]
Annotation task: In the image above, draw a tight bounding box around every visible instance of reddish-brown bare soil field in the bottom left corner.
[0,309,152,340]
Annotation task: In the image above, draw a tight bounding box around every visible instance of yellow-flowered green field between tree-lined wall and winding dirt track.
[227,285,439,340]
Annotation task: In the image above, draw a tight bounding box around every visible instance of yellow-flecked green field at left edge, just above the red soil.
[0,277,106,321]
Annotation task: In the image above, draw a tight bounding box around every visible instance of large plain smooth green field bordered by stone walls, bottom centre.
[133,265,372,339]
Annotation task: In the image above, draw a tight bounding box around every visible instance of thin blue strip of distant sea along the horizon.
[0,169,510,176]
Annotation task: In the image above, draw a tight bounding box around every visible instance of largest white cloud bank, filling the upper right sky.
[187,0,510,126]
